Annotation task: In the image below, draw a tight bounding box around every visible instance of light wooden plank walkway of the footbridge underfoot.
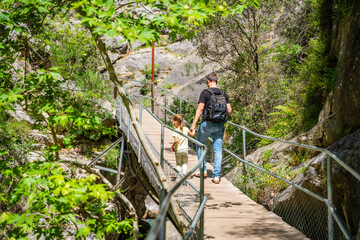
[136,111,307,240]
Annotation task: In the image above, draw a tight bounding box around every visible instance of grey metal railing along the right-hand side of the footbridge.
[109,75,360,239]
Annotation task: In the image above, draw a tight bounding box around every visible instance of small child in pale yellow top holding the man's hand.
[171,114,195,177]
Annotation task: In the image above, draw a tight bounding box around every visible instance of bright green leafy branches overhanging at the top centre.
[72,0,258,42]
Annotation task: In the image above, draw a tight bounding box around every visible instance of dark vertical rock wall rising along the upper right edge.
[308,6,360,147]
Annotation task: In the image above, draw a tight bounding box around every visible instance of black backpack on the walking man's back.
[205,88,228,122]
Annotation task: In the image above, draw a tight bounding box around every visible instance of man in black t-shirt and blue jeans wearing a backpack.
[190,73,231,184]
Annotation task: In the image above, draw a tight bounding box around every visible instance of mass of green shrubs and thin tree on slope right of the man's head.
[198,0,340,154]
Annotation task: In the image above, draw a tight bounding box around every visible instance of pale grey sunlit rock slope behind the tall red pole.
[113,40,220,101]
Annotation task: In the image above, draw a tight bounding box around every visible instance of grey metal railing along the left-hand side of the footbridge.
[116,92,207,239]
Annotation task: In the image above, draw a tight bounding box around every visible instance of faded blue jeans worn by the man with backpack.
[196,122,225,177]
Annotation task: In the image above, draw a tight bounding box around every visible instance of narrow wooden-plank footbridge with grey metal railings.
[95,79,360,239]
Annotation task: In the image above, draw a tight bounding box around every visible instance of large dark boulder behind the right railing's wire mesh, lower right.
[273,130,360,239]
